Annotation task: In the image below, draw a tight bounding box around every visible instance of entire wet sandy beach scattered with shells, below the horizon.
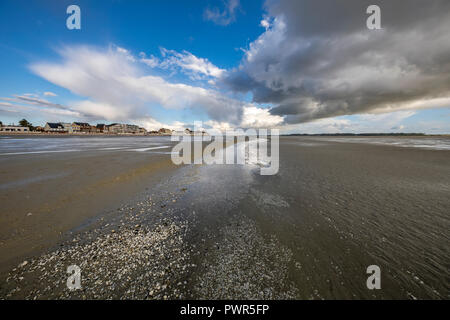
[0,136,450,299]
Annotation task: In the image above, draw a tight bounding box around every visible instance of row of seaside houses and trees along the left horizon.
[0,119,196,135]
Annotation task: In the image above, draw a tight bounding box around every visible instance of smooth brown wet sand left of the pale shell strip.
[0,137,175,271]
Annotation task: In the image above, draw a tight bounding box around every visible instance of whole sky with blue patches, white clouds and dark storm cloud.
[0,0,450,134]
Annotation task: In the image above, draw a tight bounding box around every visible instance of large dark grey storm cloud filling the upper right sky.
[222,0,450,123]
